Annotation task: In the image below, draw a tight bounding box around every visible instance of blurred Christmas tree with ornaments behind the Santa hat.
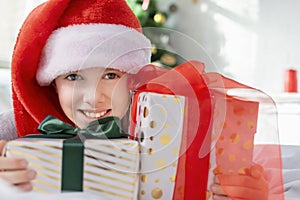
[127,0,178,67]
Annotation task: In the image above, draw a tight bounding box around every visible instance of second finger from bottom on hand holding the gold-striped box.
[0,169,36,185]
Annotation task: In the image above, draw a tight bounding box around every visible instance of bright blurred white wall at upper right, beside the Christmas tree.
[164,0,300,93]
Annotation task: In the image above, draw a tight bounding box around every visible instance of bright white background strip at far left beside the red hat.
[0,0,44,113]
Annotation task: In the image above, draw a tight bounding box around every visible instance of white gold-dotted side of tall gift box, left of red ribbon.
[130,92,185,200]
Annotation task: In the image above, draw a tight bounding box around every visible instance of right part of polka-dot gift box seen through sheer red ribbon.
[207,93,259,199]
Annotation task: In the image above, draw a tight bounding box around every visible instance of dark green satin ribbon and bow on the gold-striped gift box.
[25,115,128,191]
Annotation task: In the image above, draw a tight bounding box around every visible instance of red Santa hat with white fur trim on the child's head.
[12,0,151,136]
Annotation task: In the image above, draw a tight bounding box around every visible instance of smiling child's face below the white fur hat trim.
[55,68,130,128]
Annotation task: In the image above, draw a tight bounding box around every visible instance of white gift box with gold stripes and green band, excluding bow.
[6,138,139,199]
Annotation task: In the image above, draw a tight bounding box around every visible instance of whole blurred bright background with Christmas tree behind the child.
[0,0,300,144]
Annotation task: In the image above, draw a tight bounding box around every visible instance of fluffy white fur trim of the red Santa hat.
[36,24,151,86]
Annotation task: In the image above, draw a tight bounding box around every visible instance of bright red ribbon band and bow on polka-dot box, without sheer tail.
[129,61,212,199]
